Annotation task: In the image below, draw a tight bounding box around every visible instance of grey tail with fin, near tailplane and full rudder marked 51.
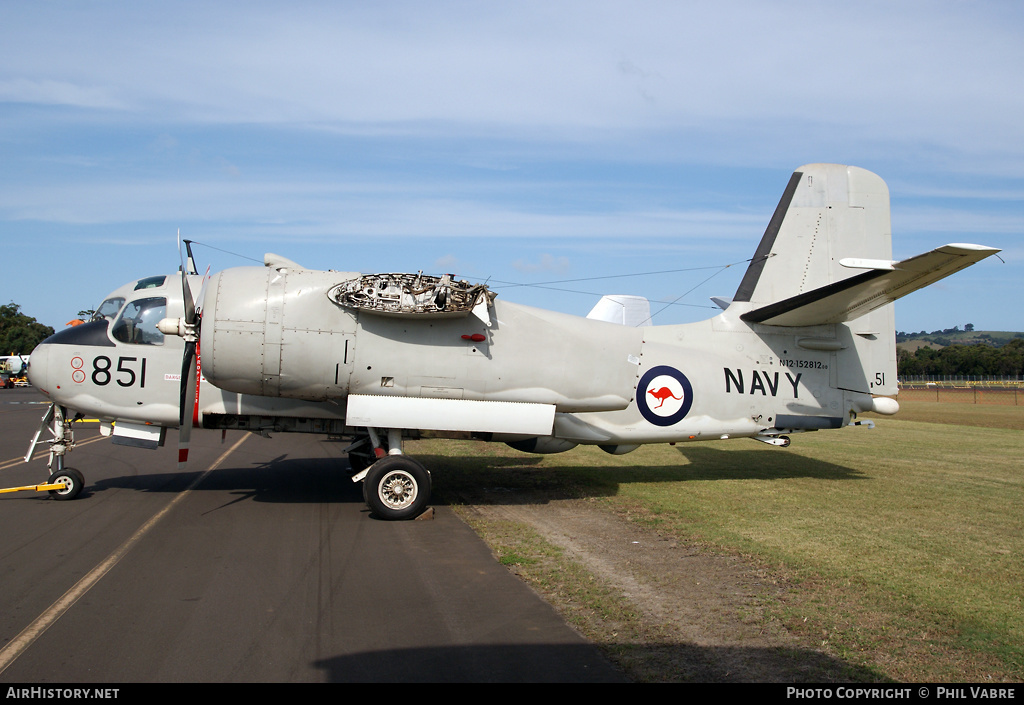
[730,164,998,401]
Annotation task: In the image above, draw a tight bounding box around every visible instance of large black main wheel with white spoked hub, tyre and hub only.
[362,455,430,521]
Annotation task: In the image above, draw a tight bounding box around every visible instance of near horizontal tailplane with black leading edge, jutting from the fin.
[739,244,999,326]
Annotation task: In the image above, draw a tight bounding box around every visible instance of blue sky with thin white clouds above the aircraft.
[0,0,1024,331]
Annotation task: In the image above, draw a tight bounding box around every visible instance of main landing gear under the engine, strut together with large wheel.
[346,428,430,521]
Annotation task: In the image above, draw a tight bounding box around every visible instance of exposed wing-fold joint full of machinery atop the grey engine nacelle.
[328,272,496,318]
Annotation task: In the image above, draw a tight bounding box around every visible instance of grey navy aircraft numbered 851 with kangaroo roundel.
[26,164,998,520]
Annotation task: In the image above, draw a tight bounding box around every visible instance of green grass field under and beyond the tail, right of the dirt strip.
[411,404,1024,681]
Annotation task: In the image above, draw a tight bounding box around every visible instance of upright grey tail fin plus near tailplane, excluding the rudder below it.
[733,164,998,326]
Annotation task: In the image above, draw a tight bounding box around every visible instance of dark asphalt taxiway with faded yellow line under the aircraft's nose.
[0,388,623,683]
